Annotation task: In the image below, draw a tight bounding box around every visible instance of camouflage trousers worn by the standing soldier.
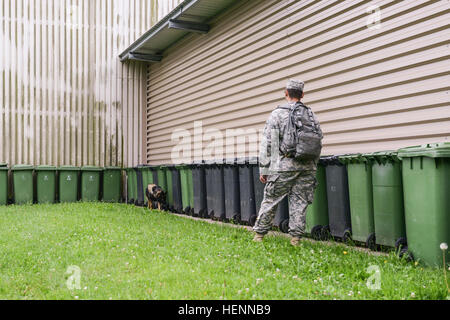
[253,171,317,237]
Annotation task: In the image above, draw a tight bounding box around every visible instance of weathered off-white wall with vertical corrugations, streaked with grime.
[0,0,179,166]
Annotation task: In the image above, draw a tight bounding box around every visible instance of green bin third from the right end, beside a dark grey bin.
[339,154,376,249]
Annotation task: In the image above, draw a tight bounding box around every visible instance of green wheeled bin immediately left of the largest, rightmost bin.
[368,151,407,252]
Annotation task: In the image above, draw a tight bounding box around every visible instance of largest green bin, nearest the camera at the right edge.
[398,142,450,267]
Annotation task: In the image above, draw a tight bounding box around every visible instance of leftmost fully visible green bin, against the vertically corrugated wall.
[11,164,34,204]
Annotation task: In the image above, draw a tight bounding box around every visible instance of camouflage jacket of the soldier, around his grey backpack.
[259,104,319,175]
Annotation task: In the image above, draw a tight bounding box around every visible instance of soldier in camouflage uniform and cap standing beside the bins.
[253,80,322,246]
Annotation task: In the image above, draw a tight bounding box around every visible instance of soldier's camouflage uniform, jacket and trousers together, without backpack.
[253,81,318,237]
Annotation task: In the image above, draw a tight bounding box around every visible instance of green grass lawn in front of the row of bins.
[0,203,448,299]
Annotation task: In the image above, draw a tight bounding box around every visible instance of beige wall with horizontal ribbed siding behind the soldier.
[147,0,450,164]
